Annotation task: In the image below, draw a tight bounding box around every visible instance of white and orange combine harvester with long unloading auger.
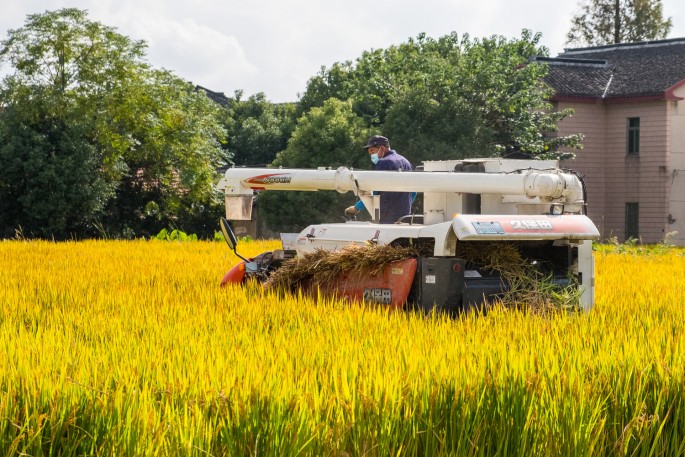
[219,159,599,313]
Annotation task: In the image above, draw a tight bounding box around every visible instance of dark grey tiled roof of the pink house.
[534,38,685,101]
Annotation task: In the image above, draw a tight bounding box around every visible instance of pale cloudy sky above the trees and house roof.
[0,0,685,102]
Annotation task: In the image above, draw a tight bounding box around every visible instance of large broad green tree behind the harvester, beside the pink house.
[302,30,580,164]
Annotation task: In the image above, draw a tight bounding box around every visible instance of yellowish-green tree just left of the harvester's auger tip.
[101,70,230,237]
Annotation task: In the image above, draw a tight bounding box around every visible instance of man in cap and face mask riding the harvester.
[345,135,416,224]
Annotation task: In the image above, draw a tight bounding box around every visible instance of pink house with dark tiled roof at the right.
[536,38,685,245]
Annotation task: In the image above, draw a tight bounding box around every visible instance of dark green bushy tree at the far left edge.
[0,90,114,237]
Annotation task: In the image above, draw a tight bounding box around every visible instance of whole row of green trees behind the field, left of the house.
[0,8,581,239]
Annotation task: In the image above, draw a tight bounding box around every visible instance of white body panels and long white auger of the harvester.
[219,159,599,310]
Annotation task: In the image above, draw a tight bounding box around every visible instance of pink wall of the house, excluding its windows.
[557,101,671,243]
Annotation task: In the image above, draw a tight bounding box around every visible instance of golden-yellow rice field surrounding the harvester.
[0,241,685,456]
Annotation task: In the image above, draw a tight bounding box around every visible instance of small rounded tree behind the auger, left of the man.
[257,98,371,232]
